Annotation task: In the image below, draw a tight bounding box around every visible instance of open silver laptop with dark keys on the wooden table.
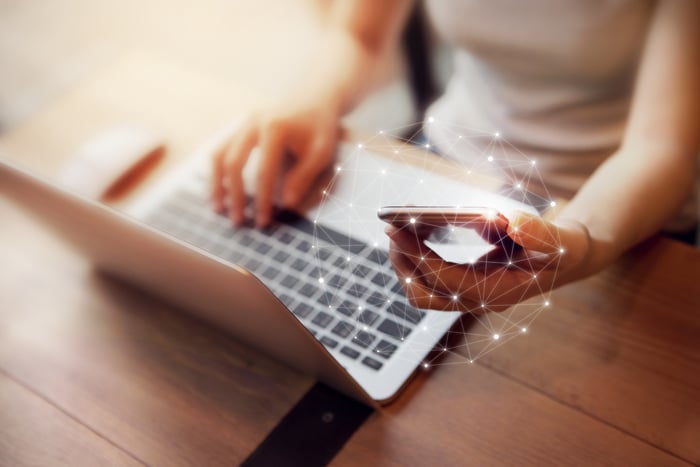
[0,124,532,406]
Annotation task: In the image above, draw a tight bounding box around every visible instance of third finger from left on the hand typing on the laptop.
[255,123,285,227]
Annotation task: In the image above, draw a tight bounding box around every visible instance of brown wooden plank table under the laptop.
[0,55,700,466]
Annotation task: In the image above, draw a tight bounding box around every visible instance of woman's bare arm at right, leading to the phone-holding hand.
[558,0,700,275]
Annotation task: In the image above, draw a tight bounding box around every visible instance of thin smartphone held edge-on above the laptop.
[377,206,512,246]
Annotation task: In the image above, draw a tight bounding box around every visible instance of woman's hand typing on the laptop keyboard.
[211,101,340,227]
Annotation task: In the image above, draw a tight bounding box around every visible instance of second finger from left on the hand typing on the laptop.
[222,126,258,225]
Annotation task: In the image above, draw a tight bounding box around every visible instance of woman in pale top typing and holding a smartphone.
[212,0,700,311]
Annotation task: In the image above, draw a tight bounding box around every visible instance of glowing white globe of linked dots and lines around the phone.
[313,117,565,368]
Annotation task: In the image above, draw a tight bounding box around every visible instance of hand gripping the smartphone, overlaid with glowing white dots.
[386,213,591,313]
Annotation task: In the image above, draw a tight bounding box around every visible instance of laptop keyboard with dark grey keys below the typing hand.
[146,176,425,370]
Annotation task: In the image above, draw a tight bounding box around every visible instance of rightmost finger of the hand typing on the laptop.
[282,133,336,209]
